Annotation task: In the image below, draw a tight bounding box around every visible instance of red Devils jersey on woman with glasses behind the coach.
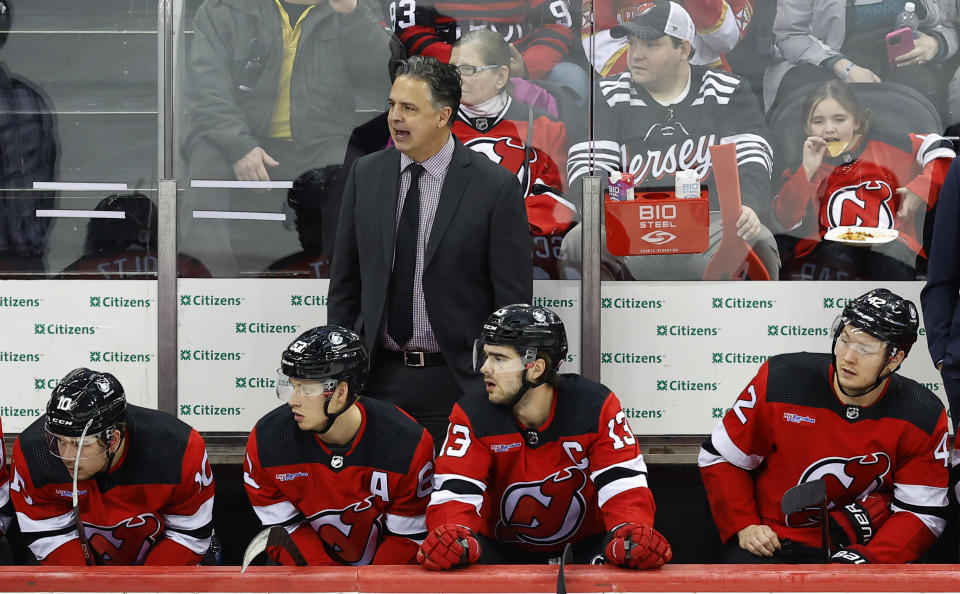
[453,96,577,235]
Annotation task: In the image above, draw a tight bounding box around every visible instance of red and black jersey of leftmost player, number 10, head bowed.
[10,405,214,565]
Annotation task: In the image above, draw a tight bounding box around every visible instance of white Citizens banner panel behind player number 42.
[600,281,947,435]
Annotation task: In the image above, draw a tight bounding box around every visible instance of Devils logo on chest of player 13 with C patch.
[496,466,587,545]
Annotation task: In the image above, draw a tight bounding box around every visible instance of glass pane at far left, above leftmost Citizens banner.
[0,0,158,279]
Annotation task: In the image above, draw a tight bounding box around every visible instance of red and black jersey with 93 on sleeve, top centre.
[386,0,576,79]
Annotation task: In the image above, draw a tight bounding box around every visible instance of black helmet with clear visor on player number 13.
[474,303,567,375]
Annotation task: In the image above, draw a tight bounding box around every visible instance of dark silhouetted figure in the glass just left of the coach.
[267,165,343,278]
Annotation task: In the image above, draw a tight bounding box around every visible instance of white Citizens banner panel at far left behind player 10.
[0,280,157,433]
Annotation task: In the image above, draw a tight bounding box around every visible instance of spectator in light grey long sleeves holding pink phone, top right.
[763,0,957,114]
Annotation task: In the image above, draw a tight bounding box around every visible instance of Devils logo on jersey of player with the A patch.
[310,495,381,565]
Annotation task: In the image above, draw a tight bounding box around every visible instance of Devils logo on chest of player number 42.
[786,452,891,526]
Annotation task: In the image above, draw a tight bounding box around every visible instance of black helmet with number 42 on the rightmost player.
[833,289,920,357]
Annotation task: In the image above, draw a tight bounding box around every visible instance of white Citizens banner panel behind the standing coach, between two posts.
[177,279,580,431]
